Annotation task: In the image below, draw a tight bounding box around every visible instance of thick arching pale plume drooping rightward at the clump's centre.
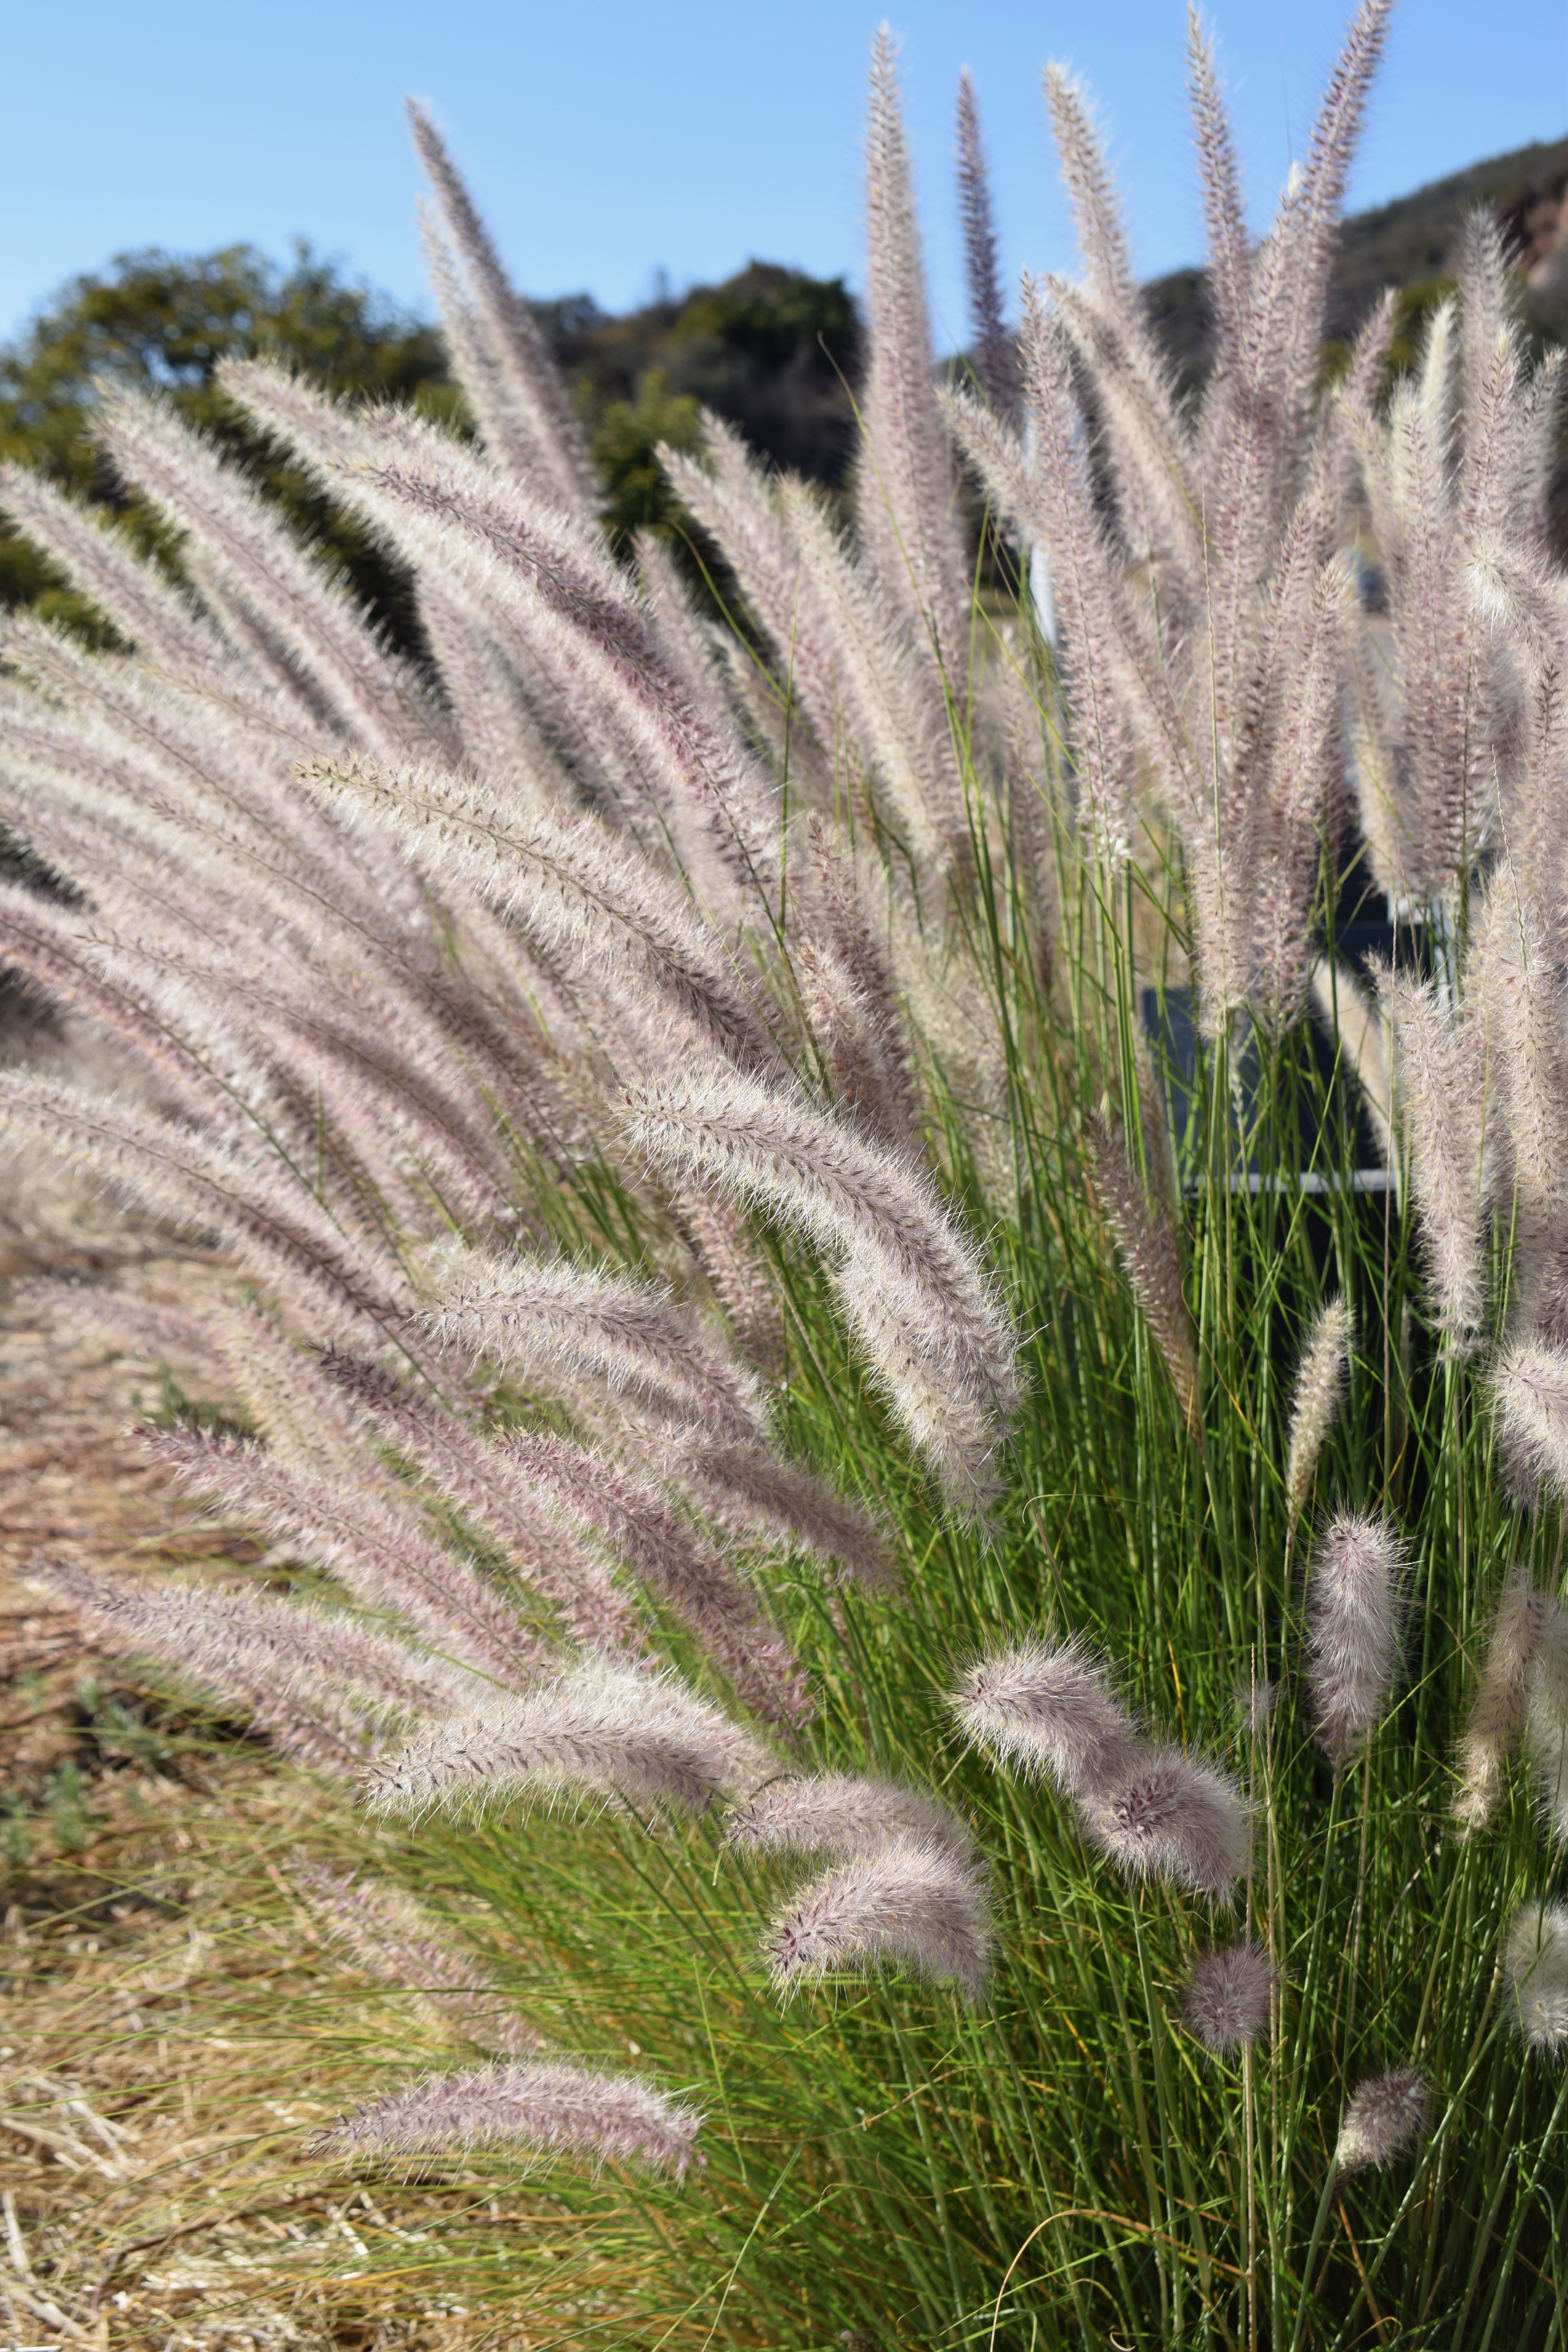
[628,1068,1018,1510]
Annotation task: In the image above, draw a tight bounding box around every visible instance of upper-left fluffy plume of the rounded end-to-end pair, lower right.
[950,1637,1143,1797]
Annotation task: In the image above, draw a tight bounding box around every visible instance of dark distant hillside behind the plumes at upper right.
[1145,139,1568,383]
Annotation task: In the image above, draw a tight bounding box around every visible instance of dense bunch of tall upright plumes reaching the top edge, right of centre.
[952,0,1389,1033]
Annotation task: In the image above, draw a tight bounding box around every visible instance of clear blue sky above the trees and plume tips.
[0,0,1568,341]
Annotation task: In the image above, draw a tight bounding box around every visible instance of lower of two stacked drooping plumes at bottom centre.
[766,1837,990,2002]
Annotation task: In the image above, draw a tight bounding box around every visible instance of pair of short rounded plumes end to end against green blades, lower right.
[952,1639,1250,1903]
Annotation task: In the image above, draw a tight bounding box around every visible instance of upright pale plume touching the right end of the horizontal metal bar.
[1377,969,1490,1350]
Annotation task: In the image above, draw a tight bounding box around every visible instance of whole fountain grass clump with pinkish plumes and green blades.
[0,0,1568,2352]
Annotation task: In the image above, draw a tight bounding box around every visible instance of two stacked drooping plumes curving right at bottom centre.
[729,1773,990,2002]
